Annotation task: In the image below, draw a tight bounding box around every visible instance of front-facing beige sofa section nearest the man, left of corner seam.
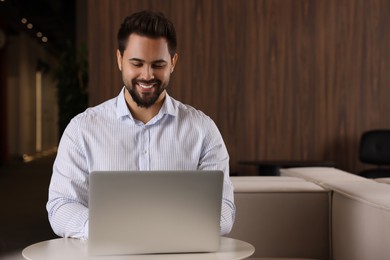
[229,176,330,260]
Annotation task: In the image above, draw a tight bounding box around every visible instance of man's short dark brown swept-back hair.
[117,11,177,57]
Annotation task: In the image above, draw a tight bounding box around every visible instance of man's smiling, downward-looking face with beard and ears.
[117,34,177,108]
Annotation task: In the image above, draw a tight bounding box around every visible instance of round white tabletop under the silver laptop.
[22,237,255,260]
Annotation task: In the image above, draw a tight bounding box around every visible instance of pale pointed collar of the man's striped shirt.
[116,87,177,121]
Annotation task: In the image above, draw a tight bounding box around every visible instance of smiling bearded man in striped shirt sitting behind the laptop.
[47,11,235,239]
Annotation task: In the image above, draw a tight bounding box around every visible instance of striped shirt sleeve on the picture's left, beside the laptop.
[46,119,89,239]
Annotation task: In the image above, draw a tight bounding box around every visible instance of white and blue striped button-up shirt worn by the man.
[46,88,235,239]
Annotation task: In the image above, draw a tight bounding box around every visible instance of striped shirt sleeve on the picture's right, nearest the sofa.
[199,119,236,235]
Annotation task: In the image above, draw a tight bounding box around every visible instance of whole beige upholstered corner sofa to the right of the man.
[229,167,390,260]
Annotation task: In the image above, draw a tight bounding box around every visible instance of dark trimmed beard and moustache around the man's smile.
[125,79,166,108]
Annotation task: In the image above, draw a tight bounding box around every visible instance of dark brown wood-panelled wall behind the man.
[87,0,390,174]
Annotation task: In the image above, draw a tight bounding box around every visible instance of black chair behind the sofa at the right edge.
[359,130,390,178]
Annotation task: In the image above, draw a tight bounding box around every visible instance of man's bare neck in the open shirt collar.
[125,90,166,124]
